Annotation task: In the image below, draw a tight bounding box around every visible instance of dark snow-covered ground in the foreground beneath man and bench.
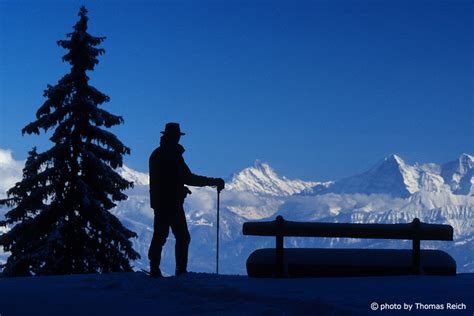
[0,272,474,316]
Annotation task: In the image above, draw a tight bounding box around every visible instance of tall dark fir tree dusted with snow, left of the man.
[0,7,139,276]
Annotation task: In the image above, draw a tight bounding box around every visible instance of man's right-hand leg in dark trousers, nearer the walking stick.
[171,206,191,275]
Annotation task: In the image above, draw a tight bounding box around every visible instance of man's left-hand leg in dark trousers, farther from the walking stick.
[148,210,170,276]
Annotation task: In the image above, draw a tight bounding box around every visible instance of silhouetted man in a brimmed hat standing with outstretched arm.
[148,123,225,277]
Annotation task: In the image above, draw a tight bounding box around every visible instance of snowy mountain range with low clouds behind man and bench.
[0,149,474,274]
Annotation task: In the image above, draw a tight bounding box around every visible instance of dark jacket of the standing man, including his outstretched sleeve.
[149,142,215,212]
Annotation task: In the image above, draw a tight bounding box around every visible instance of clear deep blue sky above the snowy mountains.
[0,0,474,180]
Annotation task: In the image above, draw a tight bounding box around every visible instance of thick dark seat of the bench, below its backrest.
[247,248,456,277]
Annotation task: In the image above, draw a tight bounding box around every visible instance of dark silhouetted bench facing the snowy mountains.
[243,216,456,277]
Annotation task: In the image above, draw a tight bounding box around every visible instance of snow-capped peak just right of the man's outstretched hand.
[227,160,318,196]
